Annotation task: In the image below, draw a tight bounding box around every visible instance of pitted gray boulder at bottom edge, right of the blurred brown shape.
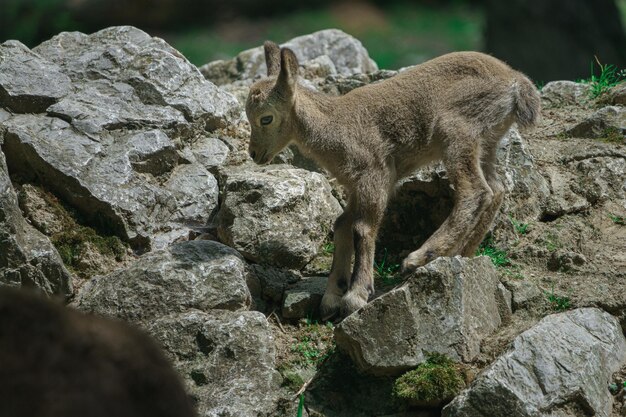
[147,310,281,417]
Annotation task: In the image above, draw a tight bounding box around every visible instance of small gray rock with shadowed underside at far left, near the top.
[0,40,71,113]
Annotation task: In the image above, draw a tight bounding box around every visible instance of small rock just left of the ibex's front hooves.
[282,277,328,319]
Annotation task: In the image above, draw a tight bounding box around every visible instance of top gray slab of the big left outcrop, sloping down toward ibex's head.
[34,26,239,127]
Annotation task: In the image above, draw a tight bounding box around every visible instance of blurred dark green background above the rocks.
[0,0,626,83]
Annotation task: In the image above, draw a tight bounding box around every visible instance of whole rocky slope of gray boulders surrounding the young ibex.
[0,27,626,416]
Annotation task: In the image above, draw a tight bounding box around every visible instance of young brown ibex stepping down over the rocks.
[246,42,540,318]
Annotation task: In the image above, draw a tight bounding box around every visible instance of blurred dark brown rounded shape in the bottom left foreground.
[0,288,196,417]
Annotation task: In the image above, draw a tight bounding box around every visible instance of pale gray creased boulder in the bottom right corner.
[442,308,626,417]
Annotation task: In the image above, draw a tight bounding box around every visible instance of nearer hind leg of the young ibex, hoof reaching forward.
[402,124,494,271]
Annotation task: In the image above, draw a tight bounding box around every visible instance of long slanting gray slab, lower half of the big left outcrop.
[3,115,219,249]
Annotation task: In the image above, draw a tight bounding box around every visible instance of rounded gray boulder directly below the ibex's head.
[216,165,341,269]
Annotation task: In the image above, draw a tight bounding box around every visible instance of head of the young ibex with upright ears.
[246,41,298,164]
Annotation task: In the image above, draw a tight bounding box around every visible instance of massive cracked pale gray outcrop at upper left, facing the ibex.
[0,27,241,250]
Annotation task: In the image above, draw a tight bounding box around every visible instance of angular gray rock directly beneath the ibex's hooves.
[335,256,510,375]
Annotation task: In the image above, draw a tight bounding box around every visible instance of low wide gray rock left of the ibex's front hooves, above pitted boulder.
[75,240,251,323]
